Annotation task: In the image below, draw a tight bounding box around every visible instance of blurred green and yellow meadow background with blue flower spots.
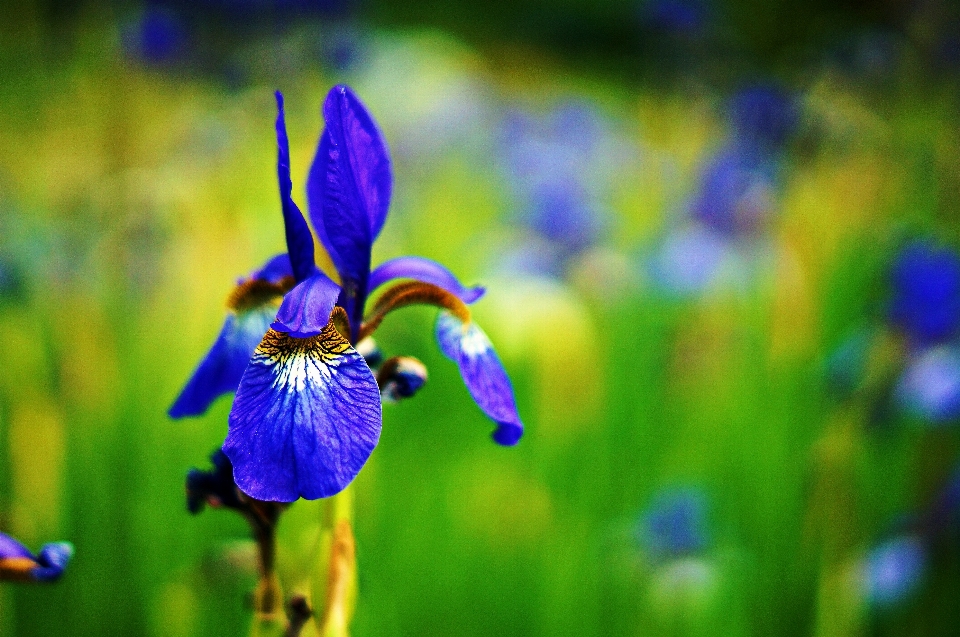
[0,0,960,637]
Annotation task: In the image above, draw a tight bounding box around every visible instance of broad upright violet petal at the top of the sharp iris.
[307,85,393,336]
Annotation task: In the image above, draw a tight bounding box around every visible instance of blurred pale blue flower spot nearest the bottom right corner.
[862,535,927,608]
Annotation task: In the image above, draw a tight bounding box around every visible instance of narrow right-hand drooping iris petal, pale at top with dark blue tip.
[437,311,523,445]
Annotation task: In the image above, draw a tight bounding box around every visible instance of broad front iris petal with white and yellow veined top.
[223,323,381,502]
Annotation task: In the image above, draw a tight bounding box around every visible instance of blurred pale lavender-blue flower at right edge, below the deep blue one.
[896,346,960,423]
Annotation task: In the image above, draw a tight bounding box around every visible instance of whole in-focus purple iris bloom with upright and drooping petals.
[170,86,523,502]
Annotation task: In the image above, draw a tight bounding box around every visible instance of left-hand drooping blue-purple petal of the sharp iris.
[169,305,276,418]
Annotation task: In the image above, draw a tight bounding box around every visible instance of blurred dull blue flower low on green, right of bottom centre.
[637,489,708,560]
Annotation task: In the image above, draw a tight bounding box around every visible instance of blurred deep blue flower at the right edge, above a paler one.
[889,241,960,346]
